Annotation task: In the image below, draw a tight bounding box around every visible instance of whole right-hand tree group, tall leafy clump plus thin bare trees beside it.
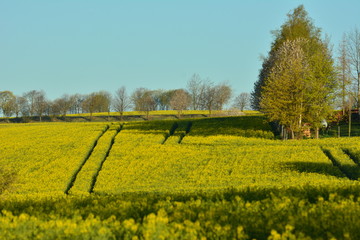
[251,5,360,138]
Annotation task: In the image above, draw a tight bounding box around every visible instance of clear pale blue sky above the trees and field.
[0,0,360,99]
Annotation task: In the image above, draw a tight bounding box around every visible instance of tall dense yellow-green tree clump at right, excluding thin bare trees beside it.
[258,5,336,138]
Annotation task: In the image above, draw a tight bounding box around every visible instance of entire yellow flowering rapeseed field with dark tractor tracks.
[0,116,360,239]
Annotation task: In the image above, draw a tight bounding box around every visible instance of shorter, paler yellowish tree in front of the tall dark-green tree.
[260,39,310,138]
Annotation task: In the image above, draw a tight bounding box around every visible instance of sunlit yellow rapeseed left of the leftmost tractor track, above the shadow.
[0,123,105,195]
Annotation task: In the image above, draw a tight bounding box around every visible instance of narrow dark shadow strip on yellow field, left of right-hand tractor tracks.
[283,162,346,178]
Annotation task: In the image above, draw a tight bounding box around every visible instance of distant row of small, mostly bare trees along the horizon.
[0,74,250,121]
